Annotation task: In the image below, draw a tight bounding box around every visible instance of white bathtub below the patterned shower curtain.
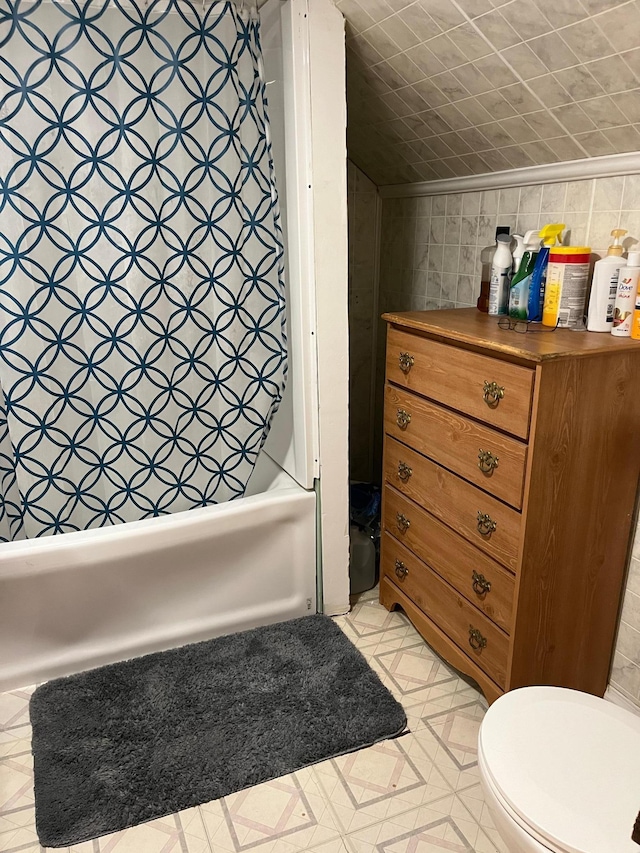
[0,453,316,690]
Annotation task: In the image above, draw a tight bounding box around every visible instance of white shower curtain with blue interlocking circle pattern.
[0,0,286,541]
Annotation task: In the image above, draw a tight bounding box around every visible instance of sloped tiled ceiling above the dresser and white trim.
[335,0,640,186]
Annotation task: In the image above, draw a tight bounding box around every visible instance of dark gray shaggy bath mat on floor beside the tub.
[30,616,406,847]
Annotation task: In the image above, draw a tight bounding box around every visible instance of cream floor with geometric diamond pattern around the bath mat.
[0,592,506,853]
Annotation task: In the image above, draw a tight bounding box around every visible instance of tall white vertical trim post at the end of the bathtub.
[306,0,349,616]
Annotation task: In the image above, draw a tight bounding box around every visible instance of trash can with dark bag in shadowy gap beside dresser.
[349,483,380,595]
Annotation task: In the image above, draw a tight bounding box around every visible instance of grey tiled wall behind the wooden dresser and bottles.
[374,175,640,707]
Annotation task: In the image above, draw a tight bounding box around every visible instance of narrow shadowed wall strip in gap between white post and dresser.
[347,156,380,482]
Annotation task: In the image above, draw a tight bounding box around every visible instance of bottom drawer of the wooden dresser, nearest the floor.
[382,533,509,688]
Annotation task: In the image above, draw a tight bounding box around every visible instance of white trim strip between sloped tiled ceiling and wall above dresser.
[378,152,640,198]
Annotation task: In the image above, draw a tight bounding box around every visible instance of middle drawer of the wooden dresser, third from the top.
[384,436,521,571]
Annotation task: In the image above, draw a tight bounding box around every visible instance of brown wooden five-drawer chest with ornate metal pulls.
[380,308,640,701]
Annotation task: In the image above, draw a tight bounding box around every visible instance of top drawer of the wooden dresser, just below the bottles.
[387,327,534,438]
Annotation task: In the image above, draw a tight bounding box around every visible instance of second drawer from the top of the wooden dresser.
[384,383,527,509]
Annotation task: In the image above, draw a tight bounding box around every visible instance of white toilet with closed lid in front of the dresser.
[478,687,640,853]
